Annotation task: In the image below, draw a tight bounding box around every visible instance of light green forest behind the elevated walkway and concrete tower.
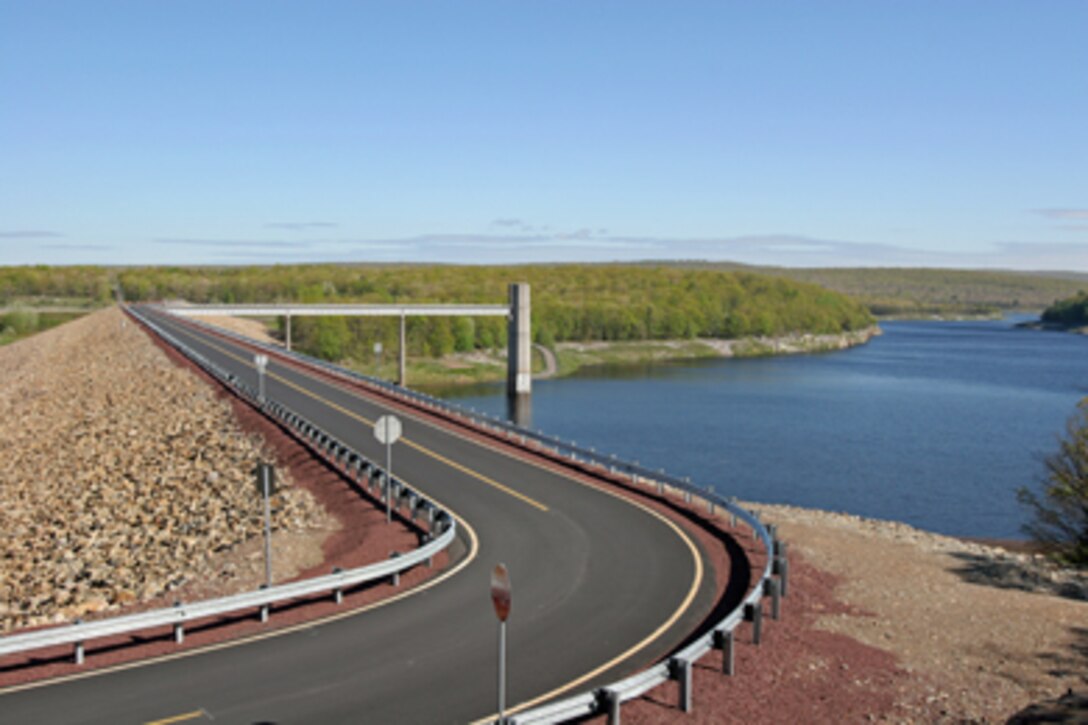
[0,265,873,359]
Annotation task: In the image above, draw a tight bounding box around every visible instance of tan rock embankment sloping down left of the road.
[0,308,330,631]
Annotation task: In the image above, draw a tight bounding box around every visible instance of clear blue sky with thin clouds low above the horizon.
[0,0,1088,271]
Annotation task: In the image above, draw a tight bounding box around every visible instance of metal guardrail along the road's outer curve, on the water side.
[158,302,789,725]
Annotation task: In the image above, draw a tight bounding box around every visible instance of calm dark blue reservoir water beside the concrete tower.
[428,319,1088,538]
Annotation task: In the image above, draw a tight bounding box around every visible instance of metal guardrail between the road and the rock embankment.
[0,308,457,664]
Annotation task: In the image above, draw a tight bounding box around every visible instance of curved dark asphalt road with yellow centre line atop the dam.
[0,306,714,724]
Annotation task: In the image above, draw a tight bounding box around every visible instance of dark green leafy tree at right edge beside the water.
[1017,400,1088,566]
